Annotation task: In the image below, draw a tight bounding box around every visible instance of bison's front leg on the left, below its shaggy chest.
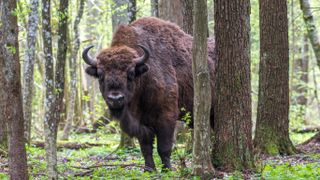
[138,133,156,171]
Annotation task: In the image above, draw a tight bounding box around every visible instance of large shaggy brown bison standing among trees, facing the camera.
[82,17,215,170]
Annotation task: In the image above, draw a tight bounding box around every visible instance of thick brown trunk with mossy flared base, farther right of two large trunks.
[254,0,296,155]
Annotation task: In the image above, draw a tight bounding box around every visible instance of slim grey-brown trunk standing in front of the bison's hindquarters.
[191,1,214,178]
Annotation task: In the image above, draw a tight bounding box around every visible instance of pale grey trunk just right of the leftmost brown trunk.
[23,0,39,143]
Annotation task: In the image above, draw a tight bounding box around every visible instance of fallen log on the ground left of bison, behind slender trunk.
[31,141,106,150]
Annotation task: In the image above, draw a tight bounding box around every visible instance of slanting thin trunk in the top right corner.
[300,0,320,68]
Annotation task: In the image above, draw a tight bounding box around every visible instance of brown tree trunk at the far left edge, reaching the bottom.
[0,0,28,179]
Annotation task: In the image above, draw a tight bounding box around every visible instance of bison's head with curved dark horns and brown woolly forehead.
[82,45,149,116]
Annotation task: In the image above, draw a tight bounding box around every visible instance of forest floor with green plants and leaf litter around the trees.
[0,129,320,180]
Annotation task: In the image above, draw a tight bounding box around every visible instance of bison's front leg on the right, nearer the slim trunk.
[157,121,175,170]
